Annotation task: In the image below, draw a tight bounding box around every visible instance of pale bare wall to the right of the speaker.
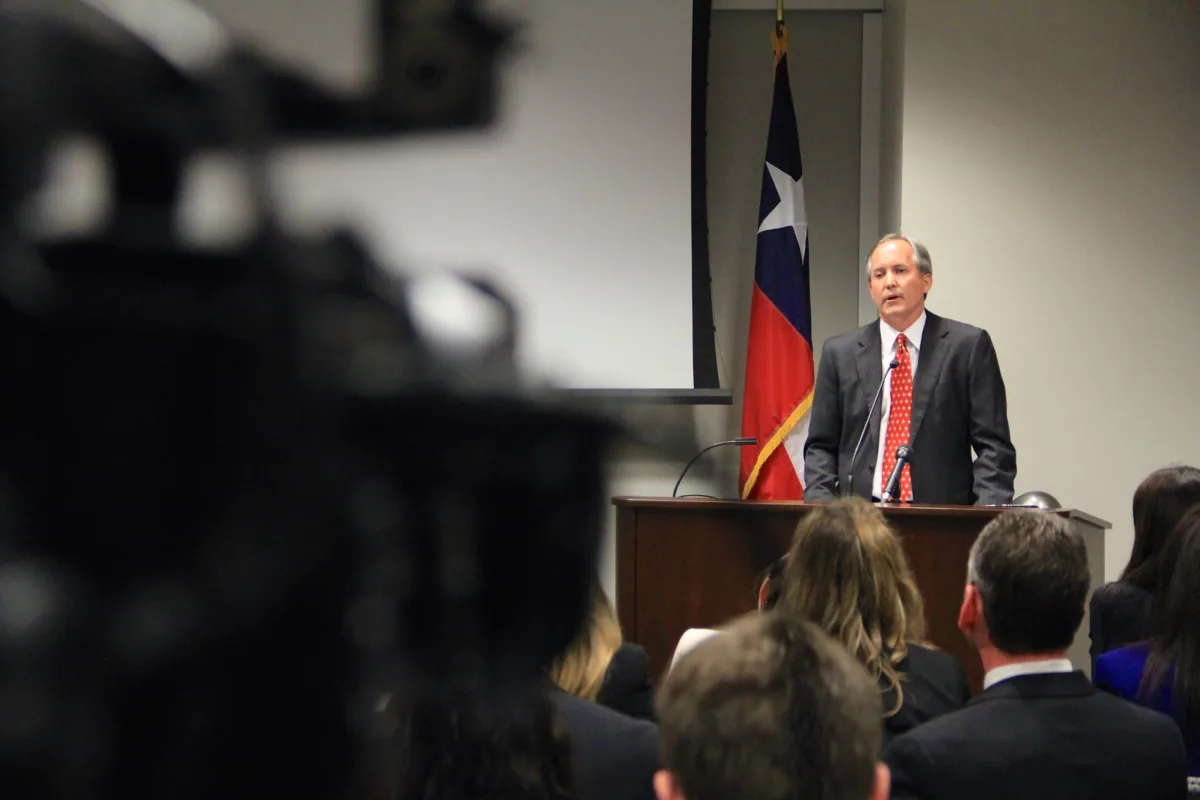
[884,0,1200,578]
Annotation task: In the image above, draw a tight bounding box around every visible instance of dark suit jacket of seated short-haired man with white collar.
[883,672,1188,800]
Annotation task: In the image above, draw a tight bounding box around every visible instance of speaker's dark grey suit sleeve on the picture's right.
[968,331,1016,504]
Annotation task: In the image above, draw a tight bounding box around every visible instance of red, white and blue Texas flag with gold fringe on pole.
[740,23,814,500]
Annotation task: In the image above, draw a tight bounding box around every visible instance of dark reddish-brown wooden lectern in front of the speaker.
[613,498,1111,692]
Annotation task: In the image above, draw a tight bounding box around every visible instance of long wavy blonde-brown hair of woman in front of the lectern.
[776,498,925,716]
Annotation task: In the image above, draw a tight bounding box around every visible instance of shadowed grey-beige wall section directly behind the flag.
[601,11,863,589]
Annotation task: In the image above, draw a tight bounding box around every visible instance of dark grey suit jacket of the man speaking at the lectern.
[804,311,1016,505]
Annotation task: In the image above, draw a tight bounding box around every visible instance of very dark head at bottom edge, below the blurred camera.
[384,680,574,800]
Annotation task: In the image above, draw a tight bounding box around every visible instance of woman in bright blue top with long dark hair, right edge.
[1092,506,1200,788]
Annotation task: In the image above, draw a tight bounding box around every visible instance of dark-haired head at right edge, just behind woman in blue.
[1121,467,1200,596]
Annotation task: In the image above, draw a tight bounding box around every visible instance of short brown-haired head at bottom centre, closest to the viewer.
[654,612,889,800]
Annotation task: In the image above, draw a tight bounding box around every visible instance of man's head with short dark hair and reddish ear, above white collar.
[959,511,1091,669]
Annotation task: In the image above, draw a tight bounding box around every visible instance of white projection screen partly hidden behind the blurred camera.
[190,0,692,390]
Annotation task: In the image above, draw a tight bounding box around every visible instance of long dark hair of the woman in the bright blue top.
[1138,505,1200,741]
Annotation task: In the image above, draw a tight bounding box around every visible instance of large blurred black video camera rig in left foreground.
[0,0,616,800]
